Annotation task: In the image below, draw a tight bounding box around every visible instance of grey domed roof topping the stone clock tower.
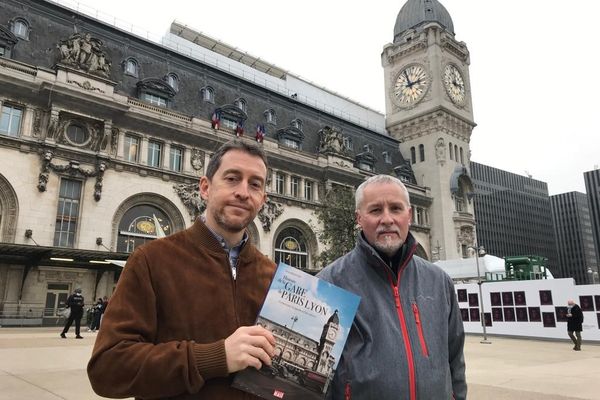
[394,0,454,42]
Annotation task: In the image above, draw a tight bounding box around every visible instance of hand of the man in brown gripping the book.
[225,326,275,373]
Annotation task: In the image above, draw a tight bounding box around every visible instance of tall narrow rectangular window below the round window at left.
[54,178,81,247]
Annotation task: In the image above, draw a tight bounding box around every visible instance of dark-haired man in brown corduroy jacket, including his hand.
[88,141,275,400]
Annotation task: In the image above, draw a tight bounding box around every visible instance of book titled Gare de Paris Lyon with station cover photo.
[232,263,360,400]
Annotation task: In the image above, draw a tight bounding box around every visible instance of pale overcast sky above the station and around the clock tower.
[58,0,600,194]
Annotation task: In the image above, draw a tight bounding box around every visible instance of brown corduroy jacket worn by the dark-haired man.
[88,219,275,400]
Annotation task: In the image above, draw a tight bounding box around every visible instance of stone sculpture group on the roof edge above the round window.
[57,33,111,78]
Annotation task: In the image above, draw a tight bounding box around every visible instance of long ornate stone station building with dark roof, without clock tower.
[0,0,432,316]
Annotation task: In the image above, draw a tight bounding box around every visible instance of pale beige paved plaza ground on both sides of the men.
[0,327,600,400]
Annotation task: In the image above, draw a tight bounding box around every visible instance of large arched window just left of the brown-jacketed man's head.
[117,204,173,253]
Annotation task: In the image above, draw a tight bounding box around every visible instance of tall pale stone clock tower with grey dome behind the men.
[381,0,476,261]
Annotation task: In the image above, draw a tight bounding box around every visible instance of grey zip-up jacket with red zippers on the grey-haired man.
[318,233,467,400]
